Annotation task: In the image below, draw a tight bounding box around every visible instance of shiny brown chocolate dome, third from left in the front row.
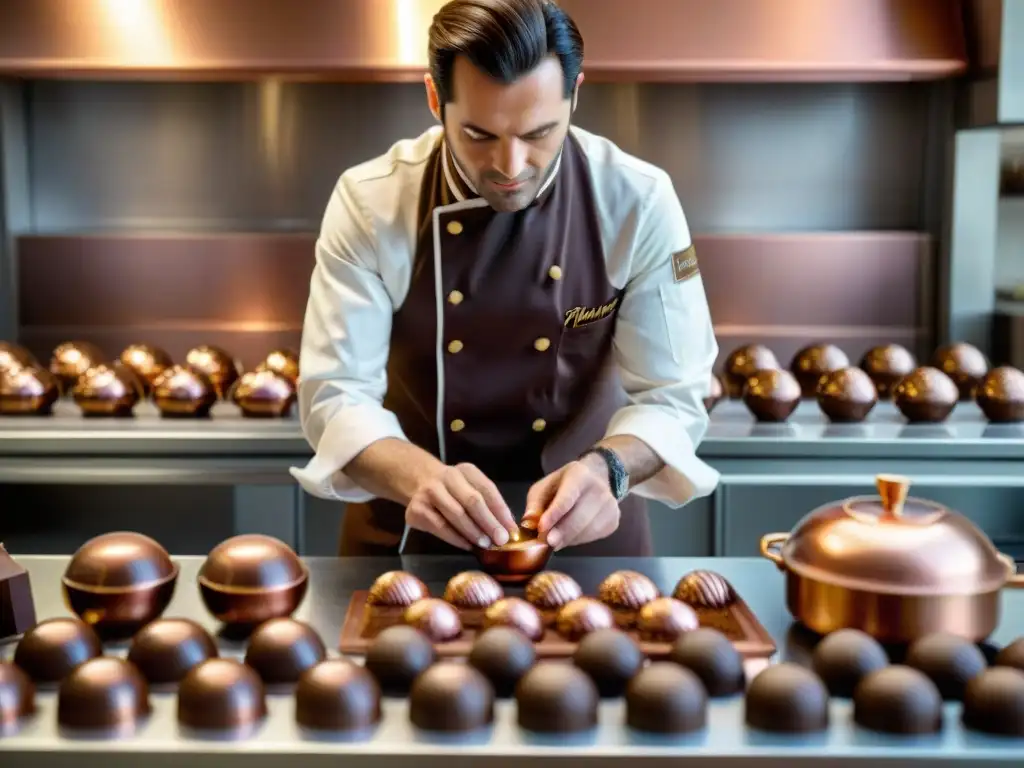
[178,658,266,731]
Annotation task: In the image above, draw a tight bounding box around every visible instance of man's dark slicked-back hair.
[428,0,583,109]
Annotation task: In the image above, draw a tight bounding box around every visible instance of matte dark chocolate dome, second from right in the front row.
[853,665,942,734]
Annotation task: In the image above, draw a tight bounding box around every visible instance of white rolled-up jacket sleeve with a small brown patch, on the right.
[606,175,719,507]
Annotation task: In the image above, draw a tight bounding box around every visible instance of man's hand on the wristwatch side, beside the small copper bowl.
[523,455,621,550]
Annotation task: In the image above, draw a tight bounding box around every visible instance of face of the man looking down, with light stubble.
[427,56,583,212]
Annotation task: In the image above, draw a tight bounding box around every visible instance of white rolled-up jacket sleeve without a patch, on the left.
[291,176,406,502]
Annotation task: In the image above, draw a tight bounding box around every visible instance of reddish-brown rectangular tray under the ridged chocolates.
[339,590,775,658]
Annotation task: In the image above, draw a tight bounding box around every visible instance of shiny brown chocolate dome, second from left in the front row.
[57,656,151,731]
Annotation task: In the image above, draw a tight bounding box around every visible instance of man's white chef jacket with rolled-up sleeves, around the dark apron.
[291,127,719,507]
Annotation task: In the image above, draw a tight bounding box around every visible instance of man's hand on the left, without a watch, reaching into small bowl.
[406,464,518,550]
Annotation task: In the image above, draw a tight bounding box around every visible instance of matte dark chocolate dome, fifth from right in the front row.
[515,662,600,733]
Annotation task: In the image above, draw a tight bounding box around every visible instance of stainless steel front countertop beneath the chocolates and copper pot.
[0,557,1024,768]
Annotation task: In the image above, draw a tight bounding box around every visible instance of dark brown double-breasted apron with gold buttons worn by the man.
[339,134,652,557]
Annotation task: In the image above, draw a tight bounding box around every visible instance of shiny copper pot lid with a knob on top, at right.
[781,475,1014,596]
